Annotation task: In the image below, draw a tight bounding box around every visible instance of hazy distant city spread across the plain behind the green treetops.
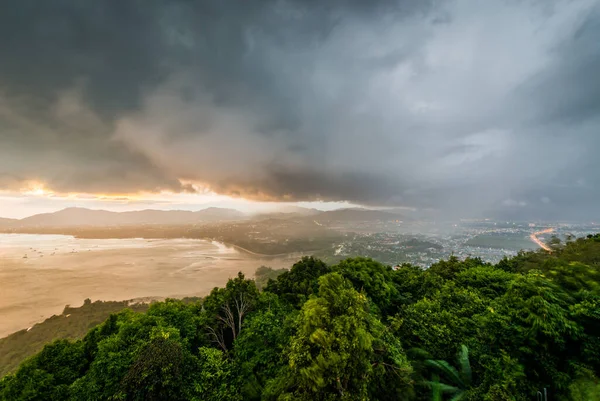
[324,220,600,268]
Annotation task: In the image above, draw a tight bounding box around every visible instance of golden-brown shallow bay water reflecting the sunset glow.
[0,234,293,337]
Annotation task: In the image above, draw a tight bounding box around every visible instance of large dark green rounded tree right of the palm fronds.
[474,271,583,397]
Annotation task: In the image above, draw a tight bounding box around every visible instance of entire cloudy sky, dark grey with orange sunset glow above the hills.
[0,0,600,219]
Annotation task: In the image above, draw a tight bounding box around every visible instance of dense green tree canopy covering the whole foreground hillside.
[0,235,600,401]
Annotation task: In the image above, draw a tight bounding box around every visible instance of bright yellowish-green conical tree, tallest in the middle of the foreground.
[280,273,410,400]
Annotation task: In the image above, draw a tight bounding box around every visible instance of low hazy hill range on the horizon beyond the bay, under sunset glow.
[10,207,246,228]
